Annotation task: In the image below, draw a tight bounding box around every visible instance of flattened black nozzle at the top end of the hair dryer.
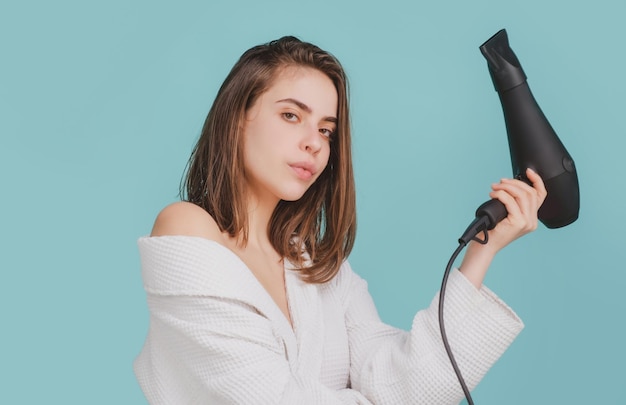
[480,29,526,91]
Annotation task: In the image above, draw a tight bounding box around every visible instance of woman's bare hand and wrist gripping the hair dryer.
[459,169,548,288]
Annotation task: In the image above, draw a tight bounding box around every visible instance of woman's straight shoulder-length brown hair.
[181,36,356,283]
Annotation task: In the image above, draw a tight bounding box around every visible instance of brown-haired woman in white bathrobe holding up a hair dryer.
[135,37,546,405]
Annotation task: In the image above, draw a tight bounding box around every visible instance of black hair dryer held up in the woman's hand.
[464,29,580,243]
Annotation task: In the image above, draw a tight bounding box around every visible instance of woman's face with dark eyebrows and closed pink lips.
[244,67,337,204]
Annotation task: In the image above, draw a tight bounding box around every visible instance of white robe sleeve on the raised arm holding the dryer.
[337,262,523,405]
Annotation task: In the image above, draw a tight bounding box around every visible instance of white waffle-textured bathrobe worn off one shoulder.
[134,236,523,405]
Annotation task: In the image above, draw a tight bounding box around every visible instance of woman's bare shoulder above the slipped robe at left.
[150,201,223,241]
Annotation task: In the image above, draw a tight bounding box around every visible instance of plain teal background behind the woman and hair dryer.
[0,0,626,405]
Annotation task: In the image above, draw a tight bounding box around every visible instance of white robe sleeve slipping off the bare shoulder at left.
[134,238,370,405]
